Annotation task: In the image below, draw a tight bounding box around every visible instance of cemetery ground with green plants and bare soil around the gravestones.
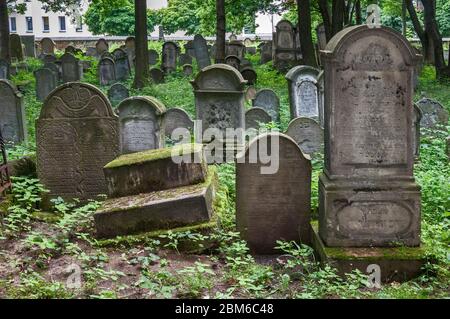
[0,43,450,298]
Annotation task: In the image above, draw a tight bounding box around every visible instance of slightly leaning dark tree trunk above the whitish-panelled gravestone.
[297,0,317,67]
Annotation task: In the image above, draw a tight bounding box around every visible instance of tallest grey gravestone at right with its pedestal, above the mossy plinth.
[319,25,421,249]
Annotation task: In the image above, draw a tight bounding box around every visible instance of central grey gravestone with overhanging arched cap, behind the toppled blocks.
[191,64,246,163]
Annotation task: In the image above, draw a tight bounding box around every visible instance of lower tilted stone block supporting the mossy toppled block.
[94,168,217,238]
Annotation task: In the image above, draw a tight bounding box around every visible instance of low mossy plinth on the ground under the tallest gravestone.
[311,224,426,283]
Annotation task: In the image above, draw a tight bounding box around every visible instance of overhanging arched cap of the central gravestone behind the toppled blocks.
[191,64,247,93]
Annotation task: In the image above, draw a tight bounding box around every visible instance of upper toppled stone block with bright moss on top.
[103,144,207,198]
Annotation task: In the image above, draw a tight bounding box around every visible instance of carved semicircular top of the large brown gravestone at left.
[39,82,117,119]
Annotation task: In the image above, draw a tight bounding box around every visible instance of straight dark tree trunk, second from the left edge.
[133,0,149,89]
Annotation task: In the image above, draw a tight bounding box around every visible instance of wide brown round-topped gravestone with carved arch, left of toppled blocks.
[36,83,120,200]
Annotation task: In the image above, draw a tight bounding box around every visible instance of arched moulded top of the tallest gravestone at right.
[321,25,420,70]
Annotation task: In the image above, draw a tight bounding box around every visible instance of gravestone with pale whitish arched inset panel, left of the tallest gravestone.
[286,65,321,121]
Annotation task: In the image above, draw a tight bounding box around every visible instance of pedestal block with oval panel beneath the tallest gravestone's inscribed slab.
[319,174,420,247]
